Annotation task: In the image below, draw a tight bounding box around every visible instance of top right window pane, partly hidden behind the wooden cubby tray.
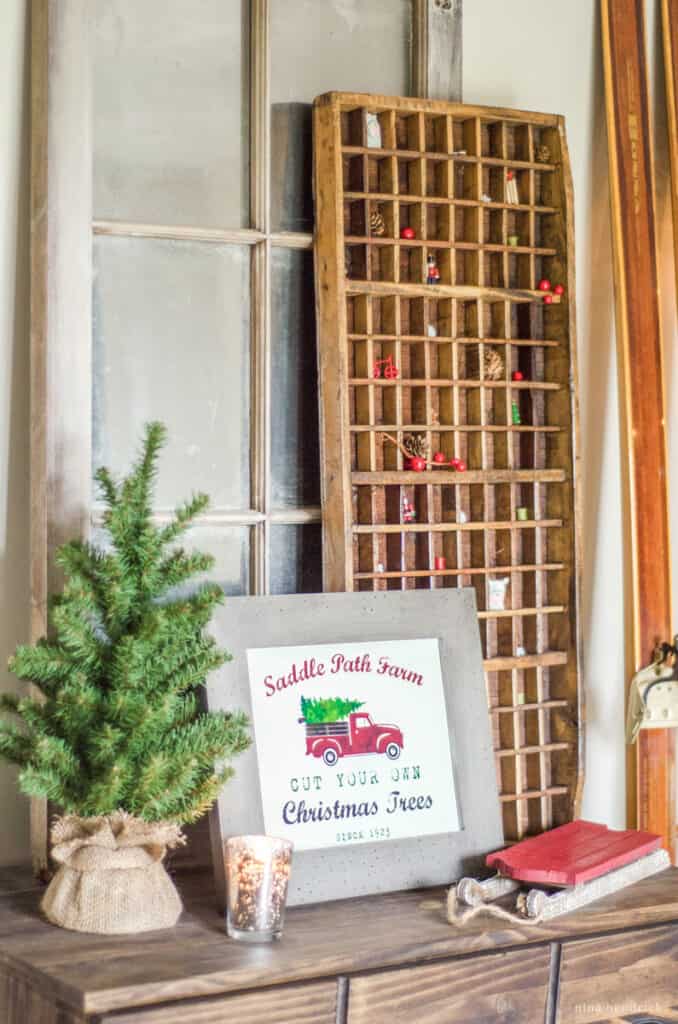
[270,0,412,231]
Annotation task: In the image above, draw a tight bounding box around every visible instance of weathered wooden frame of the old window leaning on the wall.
[26,0,462,873]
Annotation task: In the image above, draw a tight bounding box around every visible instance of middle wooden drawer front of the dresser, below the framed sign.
[348,946,550,1024]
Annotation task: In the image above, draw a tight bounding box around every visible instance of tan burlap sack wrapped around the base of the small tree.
[42,811,185,935]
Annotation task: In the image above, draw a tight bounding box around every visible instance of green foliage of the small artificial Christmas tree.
[0,423,250,930]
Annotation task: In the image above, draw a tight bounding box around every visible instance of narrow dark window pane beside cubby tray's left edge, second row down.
[270,249,321,508]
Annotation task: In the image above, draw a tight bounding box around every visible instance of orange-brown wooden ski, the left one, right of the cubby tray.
[601,0,675,853]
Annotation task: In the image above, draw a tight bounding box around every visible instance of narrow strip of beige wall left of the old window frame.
[0,0,29,864]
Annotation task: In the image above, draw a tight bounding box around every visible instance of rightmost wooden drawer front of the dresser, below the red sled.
[556,927,678,1024]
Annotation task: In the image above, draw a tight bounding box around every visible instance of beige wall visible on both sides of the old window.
[0,0,678,863]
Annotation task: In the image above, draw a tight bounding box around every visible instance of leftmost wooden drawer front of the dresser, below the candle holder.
[101,982,337,1024]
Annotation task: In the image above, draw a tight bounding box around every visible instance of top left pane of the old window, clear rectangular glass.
[94,0,249,227]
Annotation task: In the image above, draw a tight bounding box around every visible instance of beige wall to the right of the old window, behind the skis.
[464,0,678,826]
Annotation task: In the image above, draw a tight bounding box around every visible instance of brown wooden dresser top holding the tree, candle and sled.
[0,868,678,1013]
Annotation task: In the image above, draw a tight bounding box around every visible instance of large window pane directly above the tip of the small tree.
[93,237,250,509]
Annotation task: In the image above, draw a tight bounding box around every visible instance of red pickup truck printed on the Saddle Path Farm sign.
[299,712,404,766]
